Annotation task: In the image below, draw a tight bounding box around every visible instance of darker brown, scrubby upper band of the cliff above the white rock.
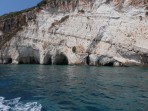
[0,0,148,47]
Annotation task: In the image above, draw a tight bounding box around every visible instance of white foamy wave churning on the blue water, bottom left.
[0,97,42,111]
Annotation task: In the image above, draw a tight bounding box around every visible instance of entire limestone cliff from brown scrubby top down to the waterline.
[0,0,148,66]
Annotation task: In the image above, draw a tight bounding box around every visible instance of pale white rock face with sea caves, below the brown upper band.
[0,0,148,66]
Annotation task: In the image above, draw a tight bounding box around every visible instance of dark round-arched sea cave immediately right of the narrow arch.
[53,54,68,65]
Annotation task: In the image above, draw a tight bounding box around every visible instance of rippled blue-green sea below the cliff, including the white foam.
[0,65,148,111]
